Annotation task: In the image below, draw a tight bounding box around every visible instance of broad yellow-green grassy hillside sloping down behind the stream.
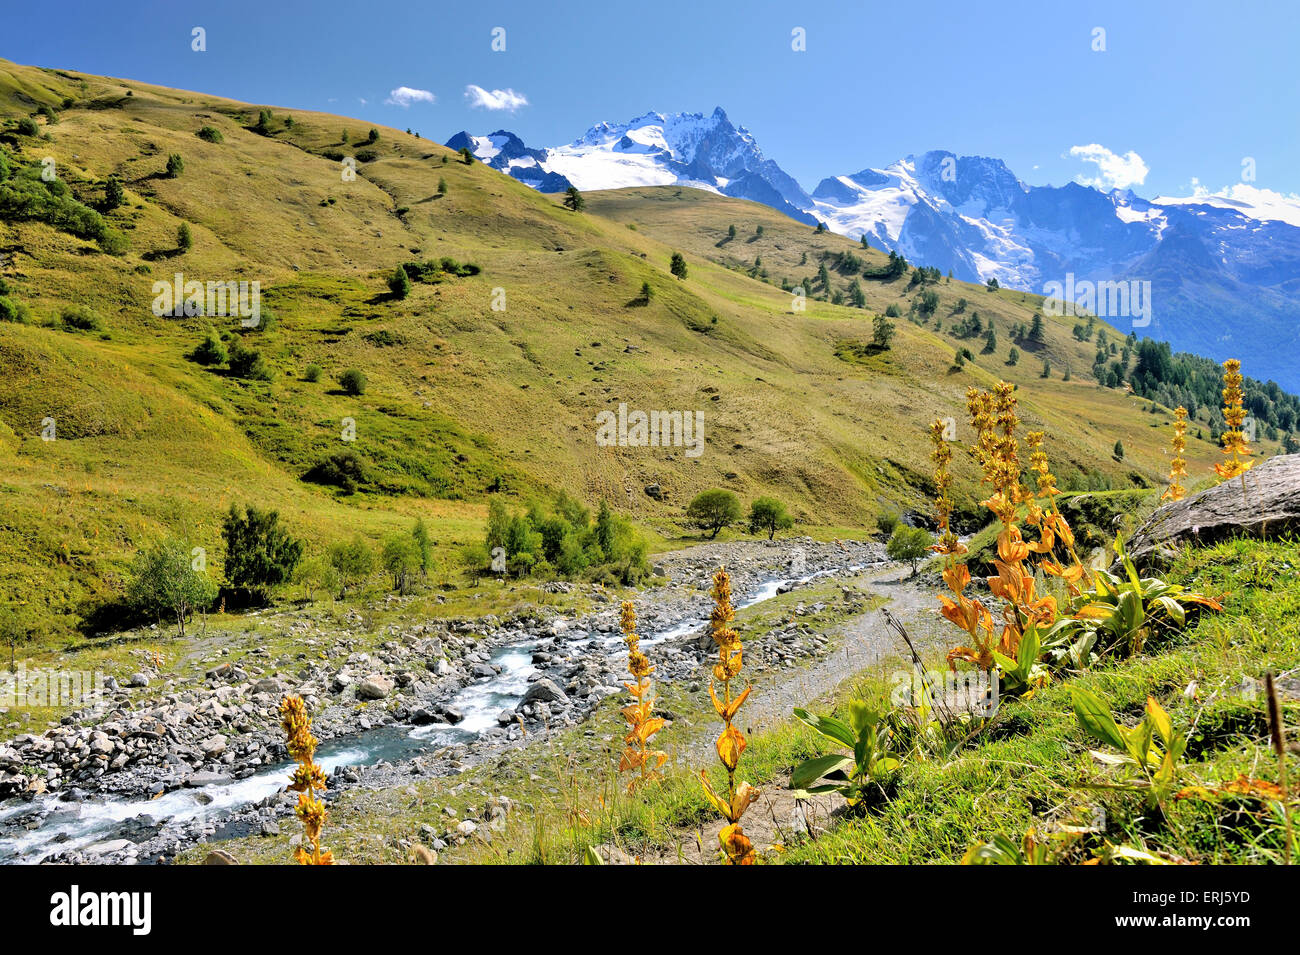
[0,61,1274,633]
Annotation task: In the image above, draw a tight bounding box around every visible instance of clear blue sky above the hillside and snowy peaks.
[0,0,1300,196]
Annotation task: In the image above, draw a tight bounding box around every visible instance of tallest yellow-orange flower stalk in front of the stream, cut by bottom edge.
[699,568,758,865]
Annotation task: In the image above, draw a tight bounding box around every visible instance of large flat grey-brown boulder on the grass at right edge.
[1128,455,1300,567]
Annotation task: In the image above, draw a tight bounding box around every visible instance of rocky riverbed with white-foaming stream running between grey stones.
[0,538,884,863]
